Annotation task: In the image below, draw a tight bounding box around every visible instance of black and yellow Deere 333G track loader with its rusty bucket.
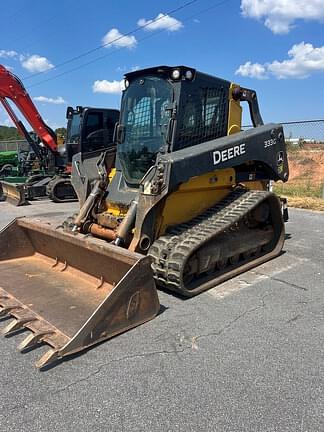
[0,66,288,367]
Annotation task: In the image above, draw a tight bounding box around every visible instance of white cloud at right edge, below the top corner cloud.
[235,42,324,79]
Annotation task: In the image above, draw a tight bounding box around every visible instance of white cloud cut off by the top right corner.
[241,0,324,34]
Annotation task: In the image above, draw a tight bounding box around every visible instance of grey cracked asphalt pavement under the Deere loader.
[0,202,324,432]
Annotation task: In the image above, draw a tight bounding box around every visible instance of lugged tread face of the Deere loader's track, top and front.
[149,189,273,294]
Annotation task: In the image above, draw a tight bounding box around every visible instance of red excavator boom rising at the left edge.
[0,65,57,156]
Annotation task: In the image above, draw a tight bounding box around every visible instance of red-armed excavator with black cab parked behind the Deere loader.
[0,65,119,205]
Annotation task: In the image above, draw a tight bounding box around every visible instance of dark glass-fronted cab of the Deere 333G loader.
[116,66,231,187]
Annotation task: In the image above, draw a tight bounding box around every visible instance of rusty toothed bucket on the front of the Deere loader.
[0,218,159,368]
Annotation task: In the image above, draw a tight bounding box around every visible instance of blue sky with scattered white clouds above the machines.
[0,0,324,128]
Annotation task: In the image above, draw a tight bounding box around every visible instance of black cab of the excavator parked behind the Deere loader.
[66,106,119,163]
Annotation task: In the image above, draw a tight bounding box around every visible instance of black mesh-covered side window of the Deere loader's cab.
[176,87,227,149]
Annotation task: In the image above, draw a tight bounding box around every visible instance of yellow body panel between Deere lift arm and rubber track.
[157,168,235,236]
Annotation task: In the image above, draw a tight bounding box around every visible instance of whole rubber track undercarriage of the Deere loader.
[149,189,284,297]
